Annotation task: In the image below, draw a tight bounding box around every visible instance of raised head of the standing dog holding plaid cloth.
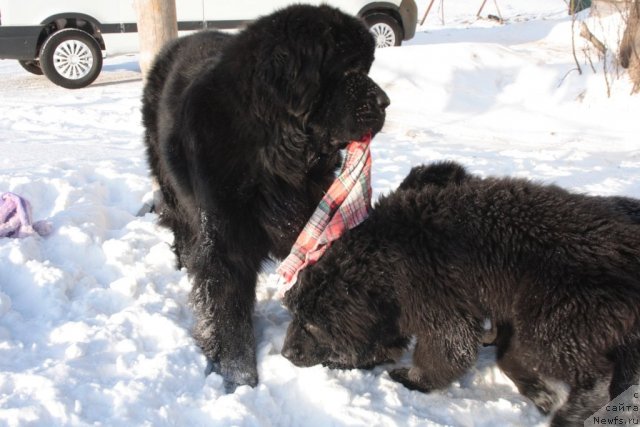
[241,5,390,153]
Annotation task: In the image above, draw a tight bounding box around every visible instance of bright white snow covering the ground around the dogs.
[0,0,640,426]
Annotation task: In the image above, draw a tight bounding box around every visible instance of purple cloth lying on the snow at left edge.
[0,193,52,237]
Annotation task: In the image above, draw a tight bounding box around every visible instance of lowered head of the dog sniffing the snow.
[282,252,408,369]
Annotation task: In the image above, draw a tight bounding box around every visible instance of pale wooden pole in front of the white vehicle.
[135,0,178,76]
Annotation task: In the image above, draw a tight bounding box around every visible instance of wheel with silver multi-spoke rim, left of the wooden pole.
[40,28,102,89]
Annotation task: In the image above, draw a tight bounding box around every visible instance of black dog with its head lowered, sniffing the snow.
[282,163,640,426]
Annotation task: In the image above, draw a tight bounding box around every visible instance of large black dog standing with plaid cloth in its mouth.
[142,5,389,391]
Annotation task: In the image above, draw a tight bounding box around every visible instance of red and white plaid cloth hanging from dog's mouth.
[277,135,371,297]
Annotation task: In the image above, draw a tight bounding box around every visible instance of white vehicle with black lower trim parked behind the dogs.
[0,0,418,89]
